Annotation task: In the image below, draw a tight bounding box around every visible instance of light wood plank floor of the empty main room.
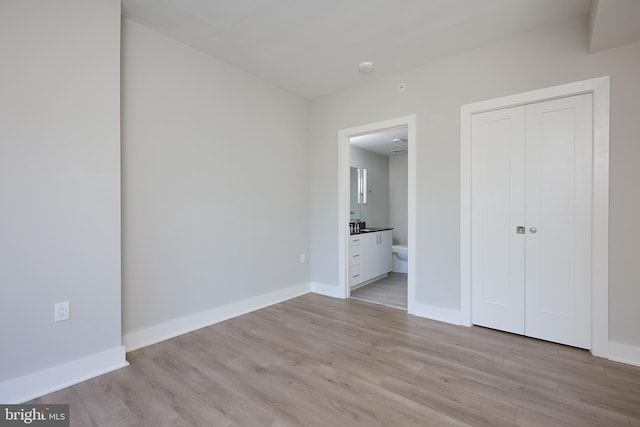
[34,294,640,427]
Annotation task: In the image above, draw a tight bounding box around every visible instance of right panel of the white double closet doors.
[525,94,593,348]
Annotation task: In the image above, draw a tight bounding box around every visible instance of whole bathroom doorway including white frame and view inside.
[338,115,416,312]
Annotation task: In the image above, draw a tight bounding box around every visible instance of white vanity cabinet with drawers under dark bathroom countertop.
[349,230,392,288]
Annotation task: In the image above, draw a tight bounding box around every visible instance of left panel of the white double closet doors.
[471,106,525,334]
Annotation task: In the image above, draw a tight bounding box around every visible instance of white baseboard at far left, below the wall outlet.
[0,346,129,404]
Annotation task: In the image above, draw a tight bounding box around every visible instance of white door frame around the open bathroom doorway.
[338,114,416,313]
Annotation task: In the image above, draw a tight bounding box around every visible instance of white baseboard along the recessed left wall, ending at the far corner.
[122,283,310,351]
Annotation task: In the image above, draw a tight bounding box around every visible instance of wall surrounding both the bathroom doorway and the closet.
[310,19,640,345]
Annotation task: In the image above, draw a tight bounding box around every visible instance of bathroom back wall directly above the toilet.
[389,155,409,246]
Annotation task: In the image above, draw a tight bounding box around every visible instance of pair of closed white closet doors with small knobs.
[471,94,593,348]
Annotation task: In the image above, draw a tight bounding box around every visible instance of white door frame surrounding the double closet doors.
[460,76,610,357]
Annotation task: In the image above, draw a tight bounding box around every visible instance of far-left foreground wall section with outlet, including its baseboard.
[0,0,124,403]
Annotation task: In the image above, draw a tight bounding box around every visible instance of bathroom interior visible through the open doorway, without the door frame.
[349,127,408,310]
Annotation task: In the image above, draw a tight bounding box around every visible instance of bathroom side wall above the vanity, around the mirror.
[349,146,389,227]
